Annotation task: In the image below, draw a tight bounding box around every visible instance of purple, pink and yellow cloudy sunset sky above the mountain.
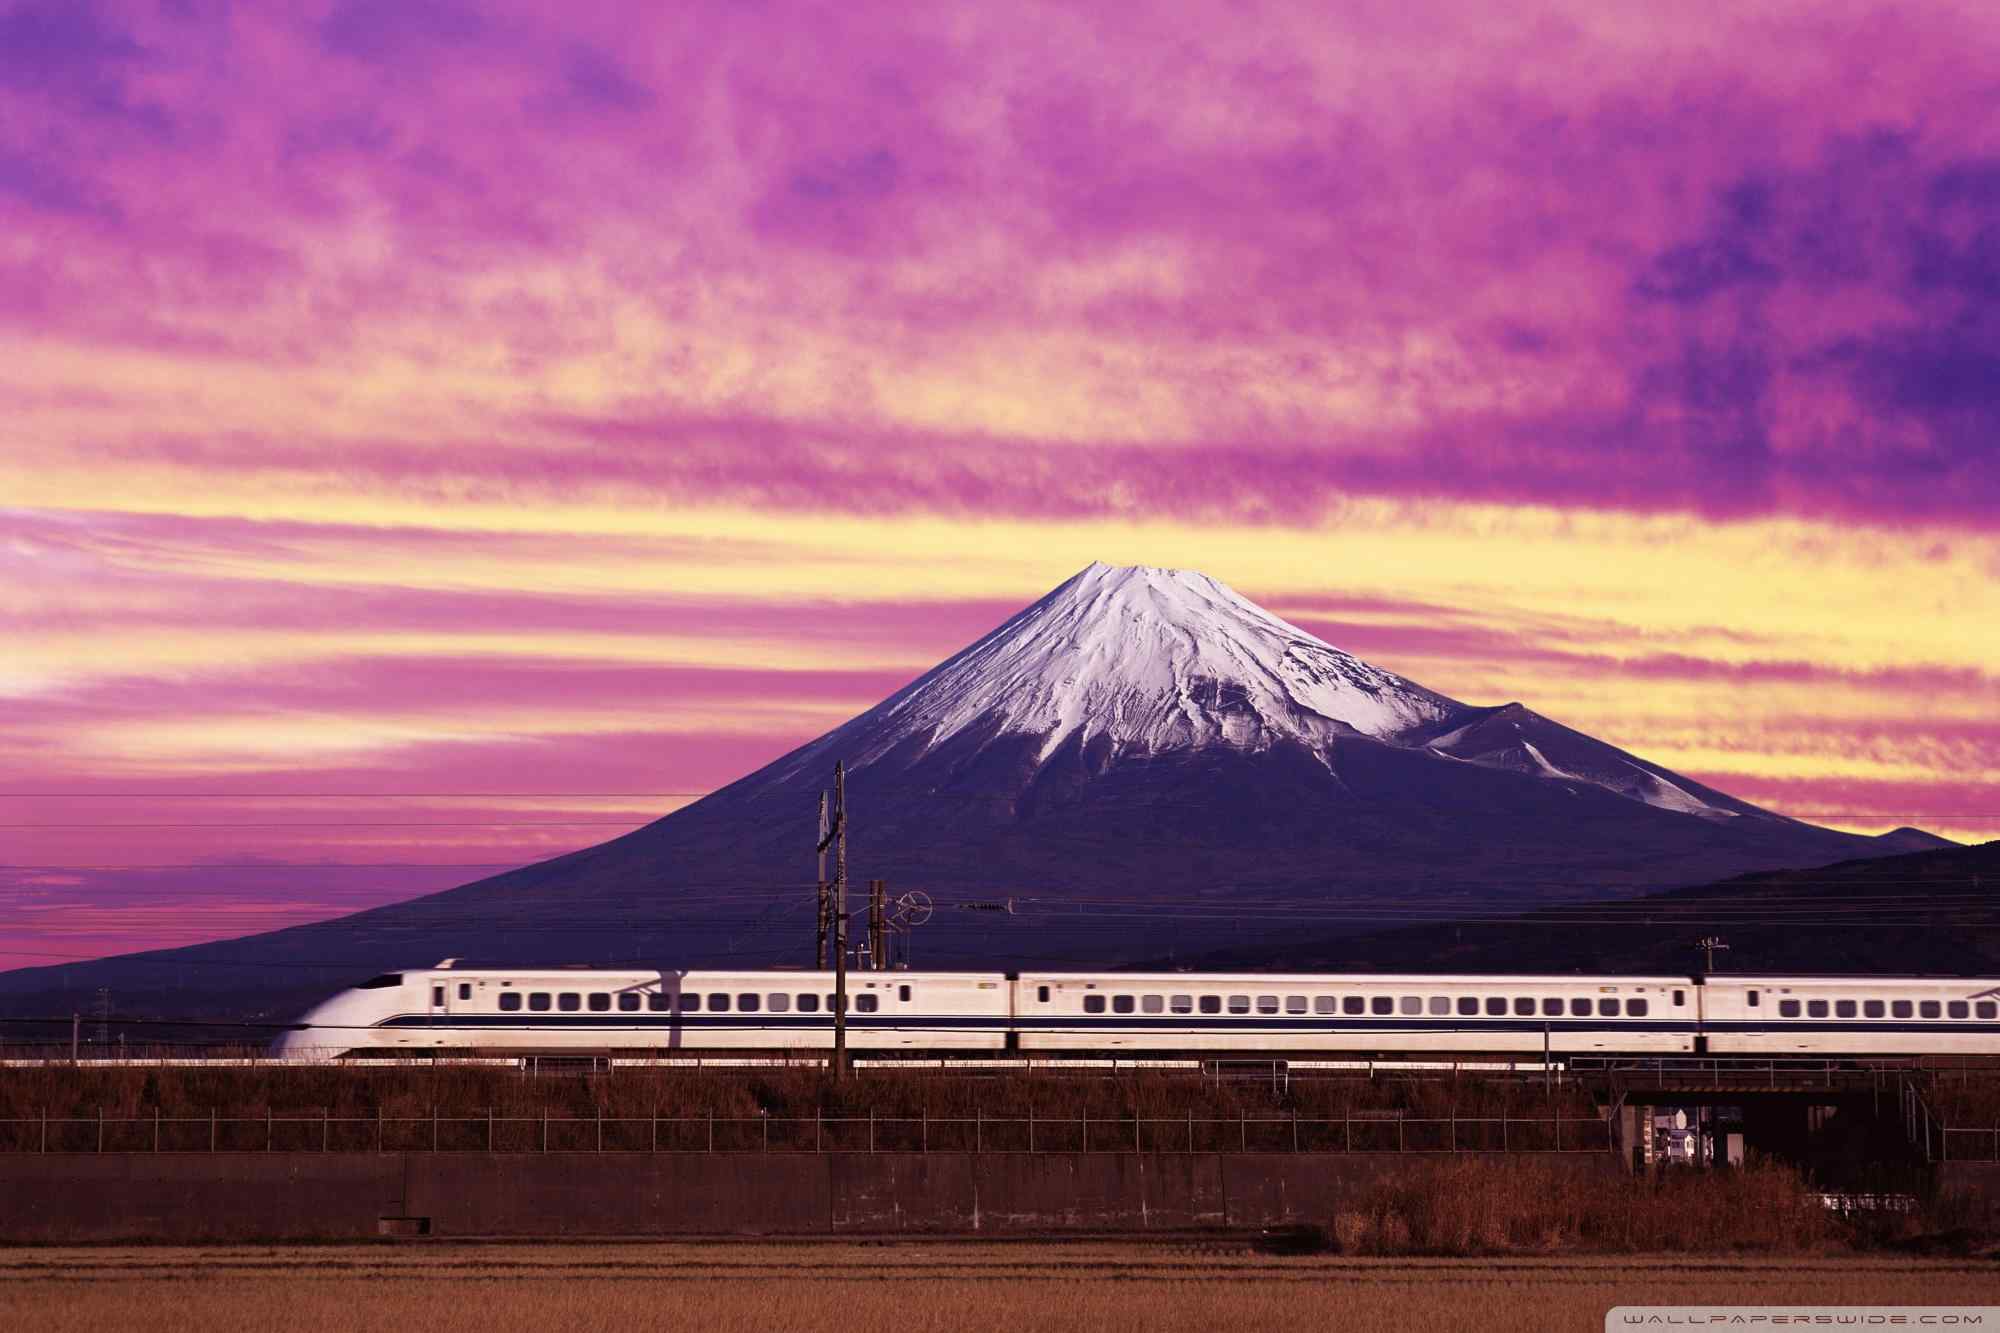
[0,0,2000,969]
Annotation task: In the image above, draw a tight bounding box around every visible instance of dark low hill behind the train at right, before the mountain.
[1176,841,2000,977]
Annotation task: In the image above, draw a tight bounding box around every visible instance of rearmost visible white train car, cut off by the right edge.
[1702,975,2000,1055]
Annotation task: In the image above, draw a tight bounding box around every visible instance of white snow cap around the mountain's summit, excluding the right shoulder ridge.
[780,564,1466,769]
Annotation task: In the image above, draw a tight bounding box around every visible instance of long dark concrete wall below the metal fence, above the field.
[0,1153,1620,1243]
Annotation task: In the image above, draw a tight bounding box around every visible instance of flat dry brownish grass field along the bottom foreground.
[0,1243,2000,1333]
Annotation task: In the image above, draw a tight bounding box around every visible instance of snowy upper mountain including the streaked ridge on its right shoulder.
[768,564,1776,819]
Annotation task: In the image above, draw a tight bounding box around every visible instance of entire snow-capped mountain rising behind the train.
[0,564,1948,1005]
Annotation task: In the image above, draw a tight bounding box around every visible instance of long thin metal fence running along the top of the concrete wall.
[0,1113,1612,1153]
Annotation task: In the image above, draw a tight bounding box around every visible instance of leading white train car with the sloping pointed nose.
[274,961,1010,1057]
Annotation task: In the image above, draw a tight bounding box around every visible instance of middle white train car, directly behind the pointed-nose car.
[1014,973,1700,1053]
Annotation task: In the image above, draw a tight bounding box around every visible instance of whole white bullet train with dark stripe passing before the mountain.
[274,959,2000,1059]
